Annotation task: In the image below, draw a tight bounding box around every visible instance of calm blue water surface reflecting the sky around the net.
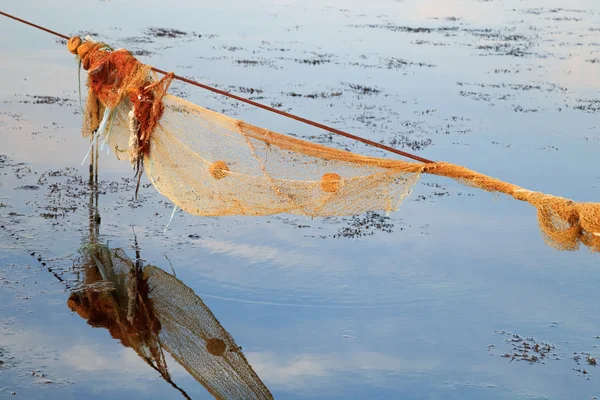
[0,0,600,399]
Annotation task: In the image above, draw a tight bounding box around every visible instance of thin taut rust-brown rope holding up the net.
[0,11,434,164]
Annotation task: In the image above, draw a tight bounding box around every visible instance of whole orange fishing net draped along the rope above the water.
[68,37,600,251]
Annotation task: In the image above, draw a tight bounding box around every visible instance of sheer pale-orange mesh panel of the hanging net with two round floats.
[104,95,421,217]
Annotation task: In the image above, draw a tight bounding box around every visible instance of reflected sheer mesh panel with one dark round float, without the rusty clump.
[144,266,273,399]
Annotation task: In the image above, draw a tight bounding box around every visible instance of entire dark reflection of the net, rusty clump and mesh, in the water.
[68,244,273,400]
